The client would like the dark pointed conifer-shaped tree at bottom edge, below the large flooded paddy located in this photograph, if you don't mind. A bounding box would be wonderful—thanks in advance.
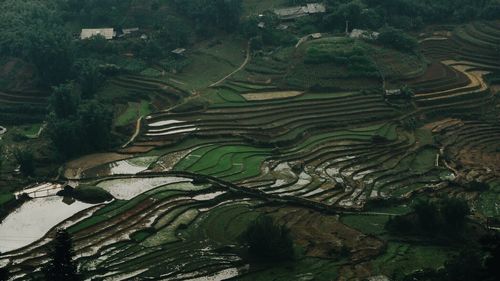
[42,229,82,281]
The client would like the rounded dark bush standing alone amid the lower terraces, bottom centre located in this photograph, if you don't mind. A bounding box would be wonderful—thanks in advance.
[242,216,294,261]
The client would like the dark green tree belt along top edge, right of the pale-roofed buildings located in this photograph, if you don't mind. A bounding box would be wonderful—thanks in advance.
[322,0,500,32]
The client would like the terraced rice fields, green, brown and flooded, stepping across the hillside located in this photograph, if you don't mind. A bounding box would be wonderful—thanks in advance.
[0,20,500,280]
